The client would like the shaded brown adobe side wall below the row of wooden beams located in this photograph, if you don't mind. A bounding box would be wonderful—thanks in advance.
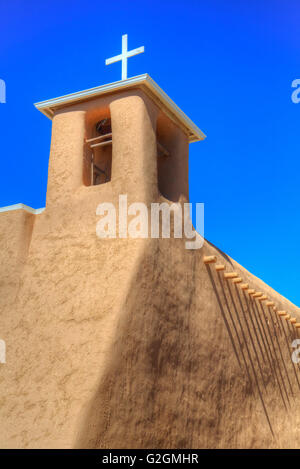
[76,239,300,449]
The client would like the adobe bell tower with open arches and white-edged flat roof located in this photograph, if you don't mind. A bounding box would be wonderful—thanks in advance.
[35,75,205,206]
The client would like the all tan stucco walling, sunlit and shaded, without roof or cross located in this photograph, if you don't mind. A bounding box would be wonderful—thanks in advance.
[0,91,300,448]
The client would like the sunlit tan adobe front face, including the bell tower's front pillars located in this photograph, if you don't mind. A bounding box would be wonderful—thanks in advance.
[0,92,186,448]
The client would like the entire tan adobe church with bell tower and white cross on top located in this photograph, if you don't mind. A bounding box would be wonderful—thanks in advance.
[0,38,300,449]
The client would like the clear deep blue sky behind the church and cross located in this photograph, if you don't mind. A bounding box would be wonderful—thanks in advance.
[0,0,300,305]
